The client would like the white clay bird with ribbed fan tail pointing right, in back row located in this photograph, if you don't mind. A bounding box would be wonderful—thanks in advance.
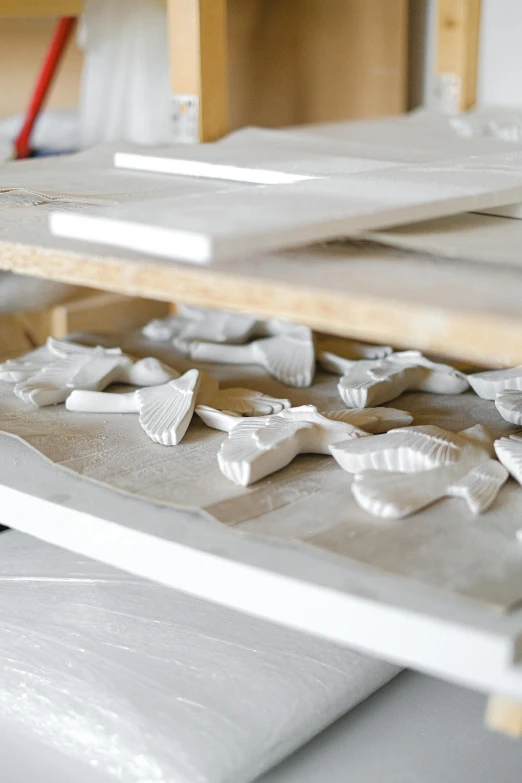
[179,326,315,387]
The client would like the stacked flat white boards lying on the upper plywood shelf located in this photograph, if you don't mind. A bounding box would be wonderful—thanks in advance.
[46,113,522,264]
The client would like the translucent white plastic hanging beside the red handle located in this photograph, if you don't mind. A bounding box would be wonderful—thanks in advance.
[79,0,172,147]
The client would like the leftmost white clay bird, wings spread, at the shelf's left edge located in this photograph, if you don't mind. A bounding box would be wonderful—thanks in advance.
[0,337,178,407]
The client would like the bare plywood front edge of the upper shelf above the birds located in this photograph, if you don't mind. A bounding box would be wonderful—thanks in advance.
[0,242,522,367]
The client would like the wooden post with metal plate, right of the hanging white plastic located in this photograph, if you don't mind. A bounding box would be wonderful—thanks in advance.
[167,0,228,141]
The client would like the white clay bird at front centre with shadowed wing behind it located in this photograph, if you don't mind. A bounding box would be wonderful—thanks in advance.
[218,405,411,487]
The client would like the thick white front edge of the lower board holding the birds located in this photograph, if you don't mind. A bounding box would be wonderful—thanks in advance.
[0,436,522,700]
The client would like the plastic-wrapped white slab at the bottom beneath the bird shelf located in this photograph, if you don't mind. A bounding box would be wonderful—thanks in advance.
[0,531,398,783]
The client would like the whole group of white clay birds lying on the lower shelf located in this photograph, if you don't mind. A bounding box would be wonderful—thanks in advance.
[0,307,522,518]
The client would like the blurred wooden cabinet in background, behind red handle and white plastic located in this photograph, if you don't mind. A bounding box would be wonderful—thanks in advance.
[0,0,408,140]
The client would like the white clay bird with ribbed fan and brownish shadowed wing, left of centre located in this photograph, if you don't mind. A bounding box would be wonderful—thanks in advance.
[66,370,290,446]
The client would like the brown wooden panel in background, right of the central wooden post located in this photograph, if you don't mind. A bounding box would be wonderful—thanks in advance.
[228,0,408,128]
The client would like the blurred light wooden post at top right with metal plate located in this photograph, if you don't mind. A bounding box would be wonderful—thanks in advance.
[437,0,482,110]
